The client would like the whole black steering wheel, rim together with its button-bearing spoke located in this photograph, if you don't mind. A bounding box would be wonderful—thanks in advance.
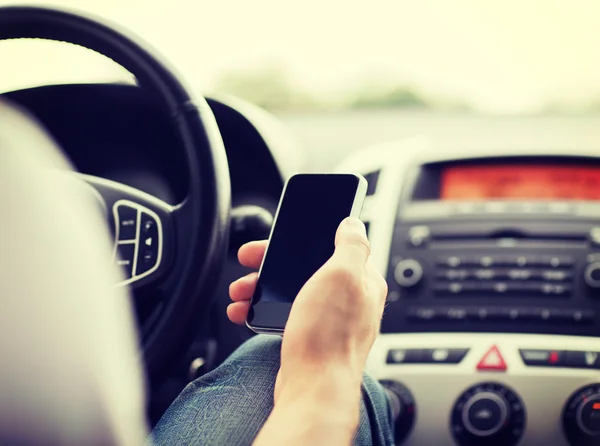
[0,7,231,381]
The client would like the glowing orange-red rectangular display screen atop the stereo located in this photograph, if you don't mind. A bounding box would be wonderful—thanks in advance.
[440,165,600,201]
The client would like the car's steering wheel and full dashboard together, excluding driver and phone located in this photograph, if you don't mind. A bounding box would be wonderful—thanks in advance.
[0,6,600,446]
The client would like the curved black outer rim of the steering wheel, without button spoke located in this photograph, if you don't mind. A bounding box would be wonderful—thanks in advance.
[0,7,231,382]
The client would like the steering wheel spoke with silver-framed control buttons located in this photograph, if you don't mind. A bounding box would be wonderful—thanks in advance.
[78,174,175,287]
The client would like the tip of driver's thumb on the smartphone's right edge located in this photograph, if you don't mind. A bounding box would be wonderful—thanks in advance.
[333,217,371,266]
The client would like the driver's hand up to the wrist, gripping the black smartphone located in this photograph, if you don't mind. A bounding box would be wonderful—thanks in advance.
[227,218,387,402]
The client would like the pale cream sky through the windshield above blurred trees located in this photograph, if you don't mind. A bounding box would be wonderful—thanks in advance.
[0,0,600,113]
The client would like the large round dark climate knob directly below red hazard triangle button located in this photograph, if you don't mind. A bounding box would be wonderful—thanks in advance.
[451,383,525,446]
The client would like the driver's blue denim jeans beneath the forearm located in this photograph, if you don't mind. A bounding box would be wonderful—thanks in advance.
[149,335,394,446]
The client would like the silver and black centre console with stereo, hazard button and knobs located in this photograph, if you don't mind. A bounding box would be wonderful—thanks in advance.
[339,145,600,446]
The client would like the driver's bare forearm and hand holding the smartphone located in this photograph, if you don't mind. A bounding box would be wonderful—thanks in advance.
[227,218,387,446]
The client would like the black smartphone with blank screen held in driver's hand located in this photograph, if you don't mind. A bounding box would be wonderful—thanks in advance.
[246,174,367,334]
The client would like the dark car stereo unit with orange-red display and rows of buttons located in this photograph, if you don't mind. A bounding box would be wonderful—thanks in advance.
[382,157,600,336]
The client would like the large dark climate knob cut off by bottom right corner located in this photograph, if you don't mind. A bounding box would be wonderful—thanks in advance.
[563,384,600,446]
